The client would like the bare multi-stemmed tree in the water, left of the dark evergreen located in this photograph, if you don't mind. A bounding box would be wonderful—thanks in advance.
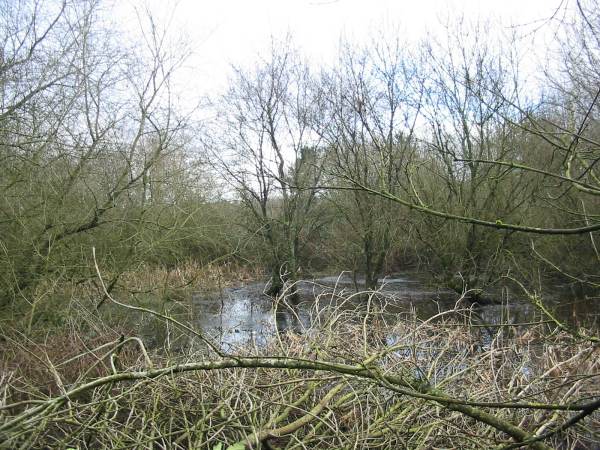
[209,44,321,294]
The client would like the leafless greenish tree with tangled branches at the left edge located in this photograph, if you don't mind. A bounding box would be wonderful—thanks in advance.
[0,1,196,314]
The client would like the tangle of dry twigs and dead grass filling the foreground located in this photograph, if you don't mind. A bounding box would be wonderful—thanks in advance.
[0,280,600,449]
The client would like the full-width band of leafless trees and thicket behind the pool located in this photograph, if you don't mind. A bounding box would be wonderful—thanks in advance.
[0,1,600,310]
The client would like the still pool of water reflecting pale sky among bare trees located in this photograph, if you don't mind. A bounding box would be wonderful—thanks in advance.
[192,273,600,351]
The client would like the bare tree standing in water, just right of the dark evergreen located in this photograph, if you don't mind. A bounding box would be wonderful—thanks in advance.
[320,40,422,289]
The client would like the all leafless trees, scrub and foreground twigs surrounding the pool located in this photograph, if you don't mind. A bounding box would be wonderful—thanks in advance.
[0,0,600,450]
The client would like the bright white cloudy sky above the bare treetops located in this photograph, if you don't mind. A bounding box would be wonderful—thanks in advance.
[115,0,564,108]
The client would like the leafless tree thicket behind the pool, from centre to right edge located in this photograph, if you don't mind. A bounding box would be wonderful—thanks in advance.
[208,17,600,296]
